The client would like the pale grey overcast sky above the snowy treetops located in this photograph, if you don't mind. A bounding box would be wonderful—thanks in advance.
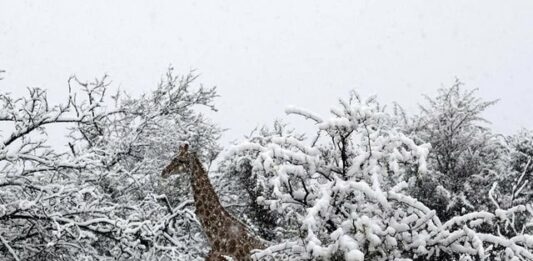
[0,0,533,145]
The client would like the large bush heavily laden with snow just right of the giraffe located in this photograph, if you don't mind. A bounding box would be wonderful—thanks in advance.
[228,90,533,260]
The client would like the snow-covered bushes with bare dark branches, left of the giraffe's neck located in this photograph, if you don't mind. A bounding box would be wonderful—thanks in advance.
[0,70,220,260]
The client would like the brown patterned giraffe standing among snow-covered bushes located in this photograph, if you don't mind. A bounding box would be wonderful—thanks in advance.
[161,144,264,261]
